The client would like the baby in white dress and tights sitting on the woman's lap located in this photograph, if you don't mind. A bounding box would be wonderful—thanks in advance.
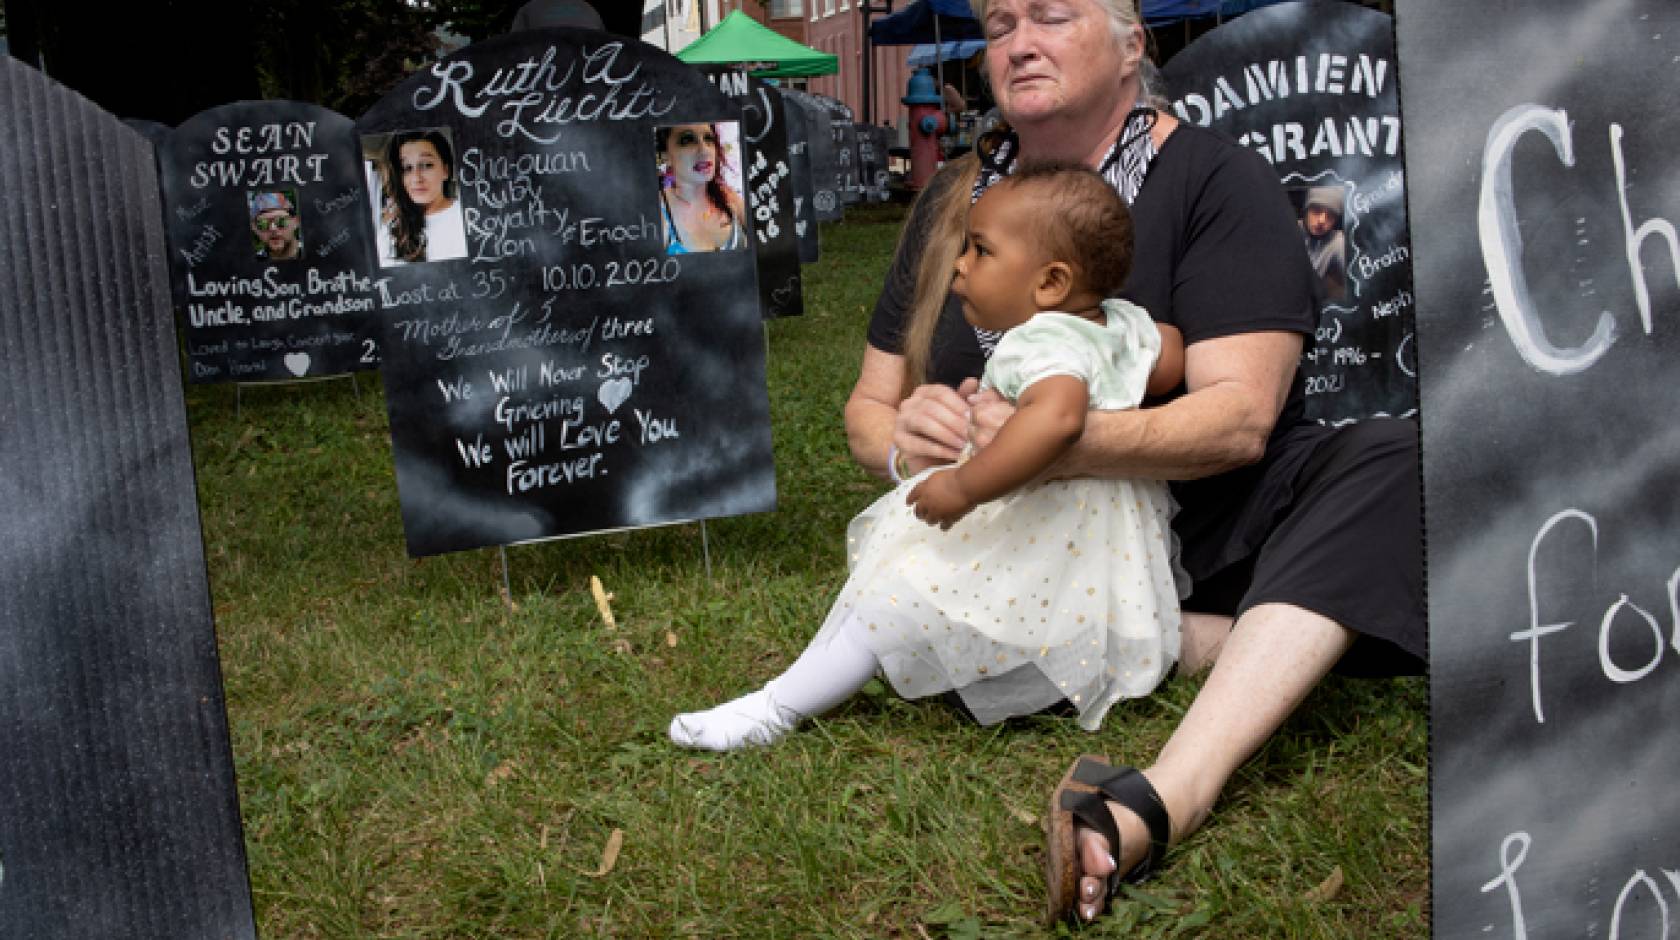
[670,166,1183,750]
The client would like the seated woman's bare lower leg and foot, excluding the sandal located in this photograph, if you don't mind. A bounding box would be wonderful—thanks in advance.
[1079,604,1354,920]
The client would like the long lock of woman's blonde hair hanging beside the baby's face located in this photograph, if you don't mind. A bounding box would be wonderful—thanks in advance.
[899,153,979,398]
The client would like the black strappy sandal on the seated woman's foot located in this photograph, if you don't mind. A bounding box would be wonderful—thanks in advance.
[1045,754,1173,925]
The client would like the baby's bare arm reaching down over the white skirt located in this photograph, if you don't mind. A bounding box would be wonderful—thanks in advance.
[907,376,1090,529]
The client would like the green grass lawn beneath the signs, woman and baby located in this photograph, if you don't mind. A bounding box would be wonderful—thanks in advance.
[188,208,1428,938]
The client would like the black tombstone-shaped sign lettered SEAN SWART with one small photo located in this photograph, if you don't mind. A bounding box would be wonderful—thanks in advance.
[158,101,380,383]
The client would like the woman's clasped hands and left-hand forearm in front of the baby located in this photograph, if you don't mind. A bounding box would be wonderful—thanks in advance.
[845,346,978,480]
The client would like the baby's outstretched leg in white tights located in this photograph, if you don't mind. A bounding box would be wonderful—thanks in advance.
[670,616,879,750]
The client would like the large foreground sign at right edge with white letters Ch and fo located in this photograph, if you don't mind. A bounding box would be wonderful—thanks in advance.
[1396,0,1680,938]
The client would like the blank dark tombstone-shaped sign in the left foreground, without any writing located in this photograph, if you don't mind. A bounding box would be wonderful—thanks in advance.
[0,55,257,940]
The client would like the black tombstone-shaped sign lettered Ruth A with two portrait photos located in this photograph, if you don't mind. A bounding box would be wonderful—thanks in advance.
[358,30,774,556]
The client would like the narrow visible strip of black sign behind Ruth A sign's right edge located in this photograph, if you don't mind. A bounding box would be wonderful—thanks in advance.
[702,67,805,319]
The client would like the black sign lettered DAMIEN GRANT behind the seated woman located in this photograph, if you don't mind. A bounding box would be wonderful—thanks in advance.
[1163,0,1418,425]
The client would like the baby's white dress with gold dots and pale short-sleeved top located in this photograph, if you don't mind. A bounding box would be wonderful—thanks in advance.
[818,300,1179,730]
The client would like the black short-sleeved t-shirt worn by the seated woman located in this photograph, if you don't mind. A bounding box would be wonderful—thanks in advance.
[869,124,1317,577]
